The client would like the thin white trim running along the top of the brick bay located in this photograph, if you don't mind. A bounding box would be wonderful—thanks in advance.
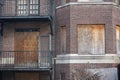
[56,2,117,9]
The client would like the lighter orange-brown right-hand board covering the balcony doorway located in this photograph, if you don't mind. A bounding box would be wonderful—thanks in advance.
[24,32,39,65]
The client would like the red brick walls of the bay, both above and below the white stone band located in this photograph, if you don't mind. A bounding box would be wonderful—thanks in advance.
[55,0,120,80]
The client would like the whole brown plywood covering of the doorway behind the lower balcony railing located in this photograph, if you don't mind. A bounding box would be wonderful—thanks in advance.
[14,32,39,66]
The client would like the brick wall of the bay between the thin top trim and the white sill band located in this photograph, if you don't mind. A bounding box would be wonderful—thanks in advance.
[56,5,116,54]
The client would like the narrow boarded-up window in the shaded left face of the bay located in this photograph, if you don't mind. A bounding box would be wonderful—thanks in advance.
[61,26,66,53]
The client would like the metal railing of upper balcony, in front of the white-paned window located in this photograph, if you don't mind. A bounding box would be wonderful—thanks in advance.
[0,0,51,17]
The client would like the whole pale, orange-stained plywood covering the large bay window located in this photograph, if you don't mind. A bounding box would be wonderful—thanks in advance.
[78,25,105,54]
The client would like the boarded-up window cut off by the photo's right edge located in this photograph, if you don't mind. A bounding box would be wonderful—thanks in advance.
[116,26,120,53]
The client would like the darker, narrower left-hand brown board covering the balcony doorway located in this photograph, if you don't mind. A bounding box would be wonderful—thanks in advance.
[14,32,25,66]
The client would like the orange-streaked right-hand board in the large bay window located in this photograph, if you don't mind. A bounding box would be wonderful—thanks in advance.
[92,25,105,54]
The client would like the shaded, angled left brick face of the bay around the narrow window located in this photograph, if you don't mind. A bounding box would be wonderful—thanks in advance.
[55,6,70,54]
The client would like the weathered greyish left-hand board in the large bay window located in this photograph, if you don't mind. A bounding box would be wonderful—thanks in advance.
[78,25,92,54]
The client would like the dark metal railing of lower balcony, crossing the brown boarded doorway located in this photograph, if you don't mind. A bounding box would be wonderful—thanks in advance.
[0,51,52,69]
